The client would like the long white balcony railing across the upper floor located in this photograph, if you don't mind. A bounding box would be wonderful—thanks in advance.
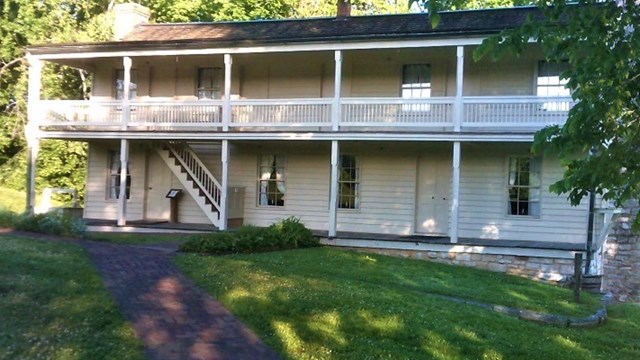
[39,96,573,131]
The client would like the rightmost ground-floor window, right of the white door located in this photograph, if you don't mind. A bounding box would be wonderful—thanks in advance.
[505,155,542,219]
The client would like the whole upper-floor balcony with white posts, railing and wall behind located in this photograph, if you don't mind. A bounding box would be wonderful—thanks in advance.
[30,38,573,137]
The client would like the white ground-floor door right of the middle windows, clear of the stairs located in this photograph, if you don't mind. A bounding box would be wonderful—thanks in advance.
[415,153,452,235]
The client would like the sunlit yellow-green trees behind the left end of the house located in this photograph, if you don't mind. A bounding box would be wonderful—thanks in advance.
[0,0,111,202]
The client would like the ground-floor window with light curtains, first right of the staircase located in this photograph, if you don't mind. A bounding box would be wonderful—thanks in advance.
[258,155,286,206]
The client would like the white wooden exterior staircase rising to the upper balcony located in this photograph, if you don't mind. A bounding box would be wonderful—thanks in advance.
[156,142,222,227]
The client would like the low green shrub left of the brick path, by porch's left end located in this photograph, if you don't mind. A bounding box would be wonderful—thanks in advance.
[13,212,86,236]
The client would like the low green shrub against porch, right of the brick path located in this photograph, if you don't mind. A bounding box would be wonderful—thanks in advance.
[180,217,319,254]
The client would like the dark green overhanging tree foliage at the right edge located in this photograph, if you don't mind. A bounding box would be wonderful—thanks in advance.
[470,0,640,228]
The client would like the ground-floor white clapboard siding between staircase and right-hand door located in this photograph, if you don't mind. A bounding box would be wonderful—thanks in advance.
[229,149,415,234]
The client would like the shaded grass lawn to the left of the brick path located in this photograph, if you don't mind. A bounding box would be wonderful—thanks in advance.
[0,235,143,359]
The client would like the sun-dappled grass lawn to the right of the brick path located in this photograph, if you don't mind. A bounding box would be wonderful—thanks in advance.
[175,248,640,360]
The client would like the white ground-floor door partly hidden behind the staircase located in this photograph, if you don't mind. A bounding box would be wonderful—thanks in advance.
[145,151,173,220]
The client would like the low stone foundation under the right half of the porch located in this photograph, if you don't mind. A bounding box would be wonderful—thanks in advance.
[349,247,573,282]
